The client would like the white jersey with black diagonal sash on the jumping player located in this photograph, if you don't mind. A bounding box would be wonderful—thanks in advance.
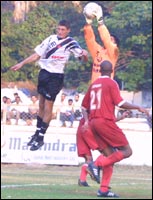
[34,35,83,73]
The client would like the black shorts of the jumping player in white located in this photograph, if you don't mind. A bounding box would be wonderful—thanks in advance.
[37,69,64,101]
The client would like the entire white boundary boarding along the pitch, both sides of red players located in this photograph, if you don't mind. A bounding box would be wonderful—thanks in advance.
[1,120,152,166]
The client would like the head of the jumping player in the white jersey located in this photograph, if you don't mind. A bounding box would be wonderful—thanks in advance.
[57,20,70,39]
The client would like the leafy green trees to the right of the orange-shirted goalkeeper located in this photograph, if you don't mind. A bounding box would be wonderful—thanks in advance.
[106,1,152,91]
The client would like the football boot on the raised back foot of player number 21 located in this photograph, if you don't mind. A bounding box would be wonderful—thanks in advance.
[87,161,100,183]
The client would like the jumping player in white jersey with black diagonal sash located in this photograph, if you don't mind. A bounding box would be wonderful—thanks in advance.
[11,20,88,151]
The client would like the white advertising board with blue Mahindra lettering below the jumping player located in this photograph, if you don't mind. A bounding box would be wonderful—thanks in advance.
[1,131,78,165]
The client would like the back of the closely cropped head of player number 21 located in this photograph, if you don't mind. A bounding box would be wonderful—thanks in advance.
[100,60,113,75]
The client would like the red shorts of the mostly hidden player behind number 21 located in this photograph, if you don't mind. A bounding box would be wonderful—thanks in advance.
[76,119,98,157]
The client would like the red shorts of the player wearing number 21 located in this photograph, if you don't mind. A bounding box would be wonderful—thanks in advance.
[90,118,129,149]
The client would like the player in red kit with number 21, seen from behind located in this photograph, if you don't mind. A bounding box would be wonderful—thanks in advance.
[82,60,149,197]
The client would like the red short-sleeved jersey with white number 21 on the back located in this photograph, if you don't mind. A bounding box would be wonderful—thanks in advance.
[82,76,125,120]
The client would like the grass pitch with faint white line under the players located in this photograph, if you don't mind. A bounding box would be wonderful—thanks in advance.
[1,164,152,199]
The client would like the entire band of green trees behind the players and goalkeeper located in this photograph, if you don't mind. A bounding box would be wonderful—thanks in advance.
[1,1,152,91]
